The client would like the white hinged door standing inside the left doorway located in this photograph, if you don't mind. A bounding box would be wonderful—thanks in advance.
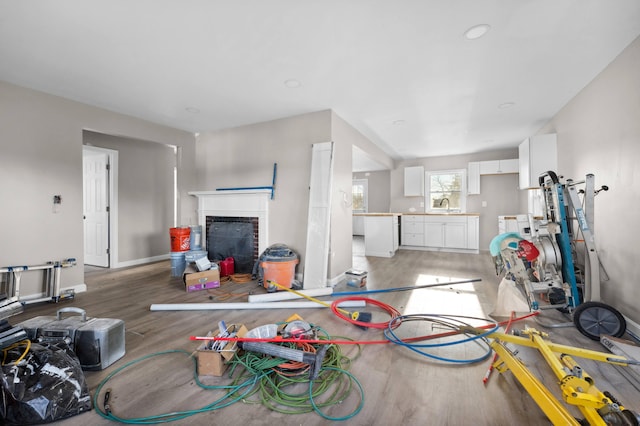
[82,148,109,267]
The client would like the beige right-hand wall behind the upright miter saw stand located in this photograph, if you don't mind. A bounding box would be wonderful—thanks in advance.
[540,38,640,332]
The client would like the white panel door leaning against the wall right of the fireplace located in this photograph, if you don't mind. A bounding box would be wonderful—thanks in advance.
[303,142,333,289]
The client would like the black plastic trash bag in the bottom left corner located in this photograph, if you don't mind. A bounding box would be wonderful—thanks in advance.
[0,341,91,425]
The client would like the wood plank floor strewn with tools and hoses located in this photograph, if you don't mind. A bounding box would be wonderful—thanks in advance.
[6,240,640,426]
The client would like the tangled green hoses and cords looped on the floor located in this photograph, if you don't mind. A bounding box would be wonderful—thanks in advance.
[93,336,364,424]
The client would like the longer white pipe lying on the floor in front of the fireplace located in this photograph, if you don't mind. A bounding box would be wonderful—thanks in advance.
[149,300,366,311]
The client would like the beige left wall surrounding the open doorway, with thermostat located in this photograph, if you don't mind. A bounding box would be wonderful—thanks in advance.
[0,82,194,295]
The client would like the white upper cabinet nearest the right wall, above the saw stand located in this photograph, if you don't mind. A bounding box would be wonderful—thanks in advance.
[518,133,558,189]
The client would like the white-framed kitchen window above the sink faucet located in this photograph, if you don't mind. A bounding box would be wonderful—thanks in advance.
[425,169,467,213]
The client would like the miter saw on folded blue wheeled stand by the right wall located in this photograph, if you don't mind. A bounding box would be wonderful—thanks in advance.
[492,171,626,340]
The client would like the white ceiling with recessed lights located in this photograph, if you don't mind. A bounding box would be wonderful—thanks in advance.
[0,0,640,170]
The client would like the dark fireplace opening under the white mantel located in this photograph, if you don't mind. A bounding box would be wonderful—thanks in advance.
[206,216,259,273]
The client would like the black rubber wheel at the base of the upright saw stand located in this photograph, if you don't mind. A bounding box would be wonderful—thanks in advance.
[573,302,627,341]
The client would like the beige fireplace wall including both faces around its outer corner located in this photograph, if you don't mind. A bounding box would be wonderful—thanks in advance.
[193,110,393,280]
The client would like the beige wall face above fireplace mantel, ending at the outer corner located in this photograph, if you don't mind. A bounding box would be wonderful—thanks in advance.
[196,111,331,280]
